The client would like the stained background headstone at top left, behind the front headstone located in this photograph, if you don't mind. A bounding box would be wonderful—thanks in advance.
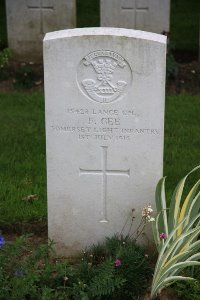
[6,0,76,61]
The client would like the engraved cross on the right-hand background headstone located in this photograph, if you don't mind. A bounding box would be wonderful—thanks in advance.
[121,0,149,29]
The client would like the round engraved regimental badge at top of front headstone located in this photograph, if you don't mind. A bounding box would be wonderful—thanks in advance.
[77,50,132,103]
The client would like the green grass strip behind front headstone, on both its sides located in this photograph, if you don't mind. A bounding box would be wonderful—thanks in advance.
[0,92,200,225]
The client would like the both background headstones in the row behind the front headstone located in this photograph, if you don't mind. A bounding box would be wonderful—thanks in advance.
[6,0,170,61]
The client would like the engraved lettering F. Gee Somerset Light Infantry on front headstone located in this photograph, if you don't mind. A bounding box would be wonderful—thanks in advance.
[50,107,161,142]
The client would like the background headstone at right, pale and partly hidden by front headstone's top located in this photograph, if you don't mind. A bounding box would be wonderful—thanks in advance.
[101,0,170,33]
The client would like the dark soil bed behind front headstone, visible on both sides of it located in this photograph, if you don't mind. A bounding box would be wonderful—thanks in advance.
[0,61,200,95]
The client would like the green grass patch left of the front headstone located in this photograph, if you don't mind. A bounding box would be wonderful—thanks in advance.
[0,92,46,224]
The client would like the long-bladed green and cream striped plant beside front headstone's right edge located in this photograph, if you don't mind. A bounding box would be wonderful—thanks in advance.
[151,166,200,298]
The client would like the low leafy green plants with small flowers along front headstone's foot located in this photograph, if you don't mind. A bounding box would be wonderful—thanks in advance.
[0,236,151,300]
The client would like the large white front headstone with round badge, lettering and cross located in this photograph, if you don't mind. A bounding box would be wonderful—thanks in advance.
[44,28,166,255]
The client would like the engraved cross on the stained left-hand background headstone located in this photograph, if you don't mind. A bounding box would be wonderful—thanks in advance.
[27,0,54,34]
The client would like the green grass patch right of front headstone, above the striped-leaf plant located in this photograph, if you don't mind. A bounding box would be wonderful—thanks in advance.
[164,95,200,180]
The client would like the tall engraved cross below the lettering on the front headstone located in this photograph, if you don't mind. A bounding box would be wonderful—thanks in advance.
[79,146,130,223]
